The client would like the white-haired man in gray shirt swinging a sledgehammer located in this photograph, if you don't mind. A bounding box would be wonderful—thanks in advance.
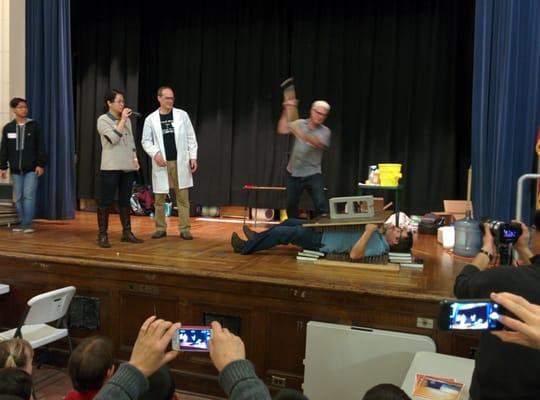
[277,99,331,218]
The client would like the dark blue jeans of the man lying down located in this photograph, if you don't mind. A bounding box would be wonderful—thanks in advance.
[242,218,322,254]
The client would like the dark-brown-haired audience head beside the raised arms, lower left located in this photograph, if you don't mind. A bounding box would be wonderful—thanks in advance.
[68,336,114,392]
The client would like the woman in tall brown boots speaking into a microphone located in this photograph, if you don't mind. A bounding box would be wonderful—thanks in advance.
[97,89,143,248]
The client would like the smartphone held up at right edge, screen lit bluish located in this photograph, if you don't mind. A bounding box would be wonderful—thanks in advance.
[439,299,505,331]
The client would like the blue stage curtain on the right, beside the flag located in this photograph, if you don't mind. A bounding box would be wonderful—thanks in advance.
[471,0,540,222]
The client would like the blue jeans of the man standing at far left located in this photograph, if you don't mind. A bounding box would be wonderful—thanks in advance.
[11,171,38,229]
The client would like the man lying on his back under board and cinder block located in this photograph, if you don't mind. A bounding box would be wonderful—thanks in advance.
[231,219,412,260]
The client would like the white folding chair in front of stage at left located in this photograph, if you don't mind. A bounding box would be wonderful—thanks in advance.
[0,286,76,352]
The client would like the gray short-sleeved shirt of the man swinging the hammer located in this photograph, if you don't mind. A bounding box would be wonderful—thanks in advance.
[287,119,331,177]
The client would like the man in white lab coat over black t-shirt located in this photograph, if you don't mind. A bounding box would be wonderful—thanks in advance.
[141,86,198,240]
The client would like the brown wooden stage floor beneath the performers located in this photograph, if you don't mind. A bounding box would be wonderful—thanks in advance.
[0,212,466,300]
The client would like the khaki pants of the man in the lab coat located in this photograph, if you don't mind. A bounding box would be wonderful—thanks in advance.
[154,161,191,233]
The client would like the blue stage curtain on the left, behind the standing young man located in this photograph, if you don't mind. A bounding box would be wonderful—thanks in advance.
[26,0,75,219]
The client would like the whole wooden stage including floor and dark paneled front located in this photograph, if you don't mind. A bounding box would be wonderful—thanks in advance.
[0,212,477,395]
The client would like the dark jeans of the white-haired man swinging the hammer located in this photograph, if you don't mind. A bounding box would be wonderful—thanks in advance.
[287,174,328,218]
